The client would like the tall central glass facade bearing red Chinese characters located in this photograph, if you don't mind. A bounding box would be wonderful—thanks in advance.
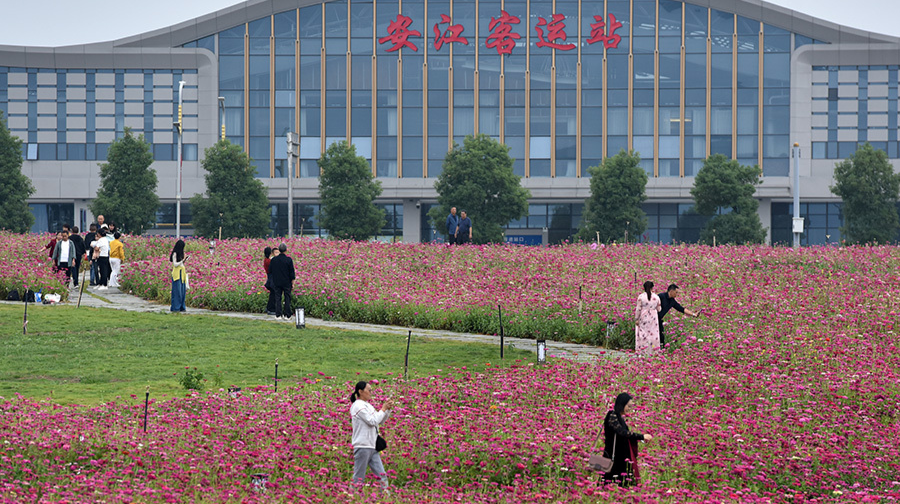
[192,0,800,178]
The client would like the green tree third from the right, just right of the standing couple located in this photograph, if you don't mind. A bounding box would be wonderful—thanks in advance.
[578,149,647,243]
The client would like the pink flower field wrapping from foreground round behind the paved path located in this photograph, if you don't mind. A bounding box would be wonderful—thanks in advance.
[0,236,900,503]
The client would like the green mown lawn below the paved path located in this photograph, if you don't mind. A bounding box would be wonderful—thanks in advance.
[0,304,534,404]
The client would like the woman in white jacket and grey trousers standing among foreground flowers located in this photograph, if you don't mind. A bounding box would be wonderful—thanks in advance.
[350,381,391,489]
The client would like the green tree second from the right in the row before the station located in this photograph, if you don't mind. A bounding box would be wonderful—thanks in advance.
[691,154,766,244]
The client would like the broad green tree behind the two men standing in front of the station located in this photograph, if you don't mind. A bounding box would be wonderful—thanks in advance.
[428,134,531,243]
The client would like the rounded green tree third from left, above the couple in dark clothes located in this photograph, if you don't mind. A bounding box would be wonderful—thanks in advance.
[191,139,269,238]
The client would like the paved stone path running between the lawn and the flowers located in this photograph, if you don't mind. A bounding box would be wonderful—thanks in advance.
[31,286,629,361]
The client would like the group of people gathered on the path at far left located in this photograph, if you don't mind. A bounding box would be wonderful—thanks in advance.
[44,215,125,290]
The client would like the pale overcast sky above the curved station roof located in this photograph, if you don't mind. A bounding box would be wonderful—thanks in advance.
[0,0,900,46]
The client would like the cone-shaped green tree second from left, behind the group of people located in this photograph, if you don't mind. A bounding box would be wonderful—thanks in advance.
[89,128,159,234]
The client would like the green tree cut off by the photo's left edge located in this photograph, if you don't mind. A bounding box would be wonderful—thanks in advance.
[0,111,34,233]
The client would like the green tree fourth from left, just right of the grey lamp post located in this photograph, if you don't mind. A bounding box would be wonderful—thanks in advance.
[319,140,385,241]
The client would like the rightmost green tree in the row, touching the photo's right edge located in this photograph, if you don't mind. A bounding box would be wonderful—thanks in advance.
[831,142,900,243]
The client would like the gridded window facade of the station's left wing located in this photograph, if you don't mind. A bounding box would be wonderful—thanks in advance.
[0,67,198,161]
